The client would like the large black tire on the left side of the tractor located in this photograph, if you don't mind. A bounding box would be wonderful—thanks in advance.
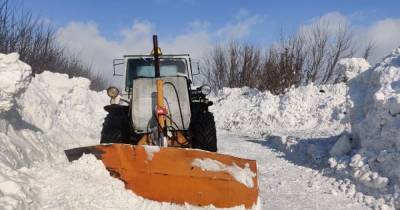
[100,104,132,144]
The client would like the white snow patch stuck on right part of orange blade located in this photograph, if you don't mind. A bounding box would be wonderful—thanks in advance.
[192,158,256,188]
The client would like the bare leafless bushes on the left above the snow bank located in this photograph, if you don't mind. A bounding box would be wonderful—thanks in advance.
[0,0,107,90]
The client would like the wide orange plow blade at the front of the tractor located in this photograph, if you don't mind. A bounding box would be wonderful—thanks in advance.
[65,144,258,209]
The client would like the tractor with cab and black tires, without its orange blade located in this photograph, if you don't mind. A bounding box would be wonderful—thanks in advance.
[100,34,217,152]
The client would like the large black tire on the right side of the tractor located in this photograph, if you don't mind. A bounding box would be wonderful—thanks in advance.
[190,110,217,152]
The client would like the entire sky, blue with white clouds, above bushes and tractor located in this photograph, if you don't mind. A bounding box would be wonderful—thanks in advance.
[9,0,400,79]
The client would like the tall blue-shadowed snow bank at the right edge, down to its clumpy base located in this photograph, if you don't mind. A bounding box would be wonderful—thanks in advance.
[348,48,400,192]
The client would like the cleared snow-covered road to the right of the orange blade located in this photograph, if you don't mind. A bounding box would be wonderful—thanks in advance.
[218,130,370,210]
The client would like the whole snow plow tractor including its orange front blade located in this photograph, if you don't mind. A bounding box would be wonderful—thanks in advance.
[65,35,259,209]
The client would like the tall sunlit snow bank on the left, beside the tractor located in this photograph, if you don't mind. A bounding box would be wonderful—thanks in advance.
[0,53,108,209]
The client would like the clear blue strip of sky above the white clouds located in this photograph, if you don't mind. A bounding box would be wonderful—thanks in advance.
[14,0,400,43]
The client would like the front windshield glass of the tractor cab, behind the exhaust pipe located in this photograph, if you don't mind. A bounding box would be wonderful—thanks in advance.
[126,58,187,88]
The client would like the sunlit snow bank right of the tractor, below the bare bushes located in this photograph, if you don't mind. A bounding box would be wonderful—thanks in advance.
[211,84,347,137]
